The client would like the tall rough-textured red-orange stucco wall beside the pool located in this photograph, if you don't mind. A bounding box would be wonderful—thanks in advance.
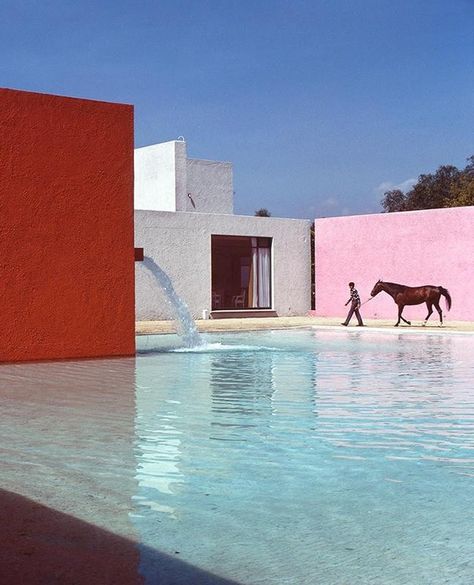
[0,89,135,361]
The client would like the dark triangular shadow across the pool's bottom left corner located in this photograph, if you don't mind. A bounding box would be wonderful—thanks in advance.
[0,490,243,585]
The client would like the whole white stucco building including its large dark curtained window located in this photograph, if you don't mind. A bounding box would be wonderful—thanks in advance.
[135,140,311,321]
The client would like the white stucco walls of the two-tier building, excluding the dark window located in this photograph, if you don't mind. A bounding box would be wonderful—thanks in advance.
[135,140,311,321]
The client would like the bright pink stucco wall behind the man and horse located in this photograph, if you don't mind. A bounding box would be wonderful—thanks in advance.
[315,207,474,321]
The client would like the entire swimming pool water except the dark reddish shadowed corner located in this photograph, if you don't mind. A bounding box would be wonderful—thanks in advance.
[0,329,474,585]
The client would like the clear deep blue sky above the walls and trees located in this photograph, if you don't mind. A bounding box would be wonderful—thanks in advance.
[0,0,474,218]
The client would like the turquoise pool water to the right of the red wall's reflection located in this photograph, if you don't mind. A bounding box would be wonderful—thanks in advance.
[133,329,474,585]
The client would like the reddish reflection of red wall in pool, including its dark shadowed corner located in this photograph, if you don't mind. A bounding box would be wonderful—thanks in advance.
[0,358,142,585]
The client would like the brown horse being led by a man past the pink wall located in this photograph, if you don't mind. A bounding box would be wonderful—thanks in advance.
[370,280,451,327]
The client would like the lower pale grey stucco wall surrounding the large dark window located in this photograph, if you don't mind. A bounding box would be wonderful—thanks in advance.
[135,210,311,321]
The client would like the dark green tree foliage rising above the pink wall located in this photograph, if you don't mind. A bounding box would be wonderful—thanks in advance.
[381,156,474,212]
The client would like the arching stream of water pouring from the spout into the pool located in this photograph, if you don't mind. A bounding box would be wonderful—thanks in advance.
[143,256,203,347]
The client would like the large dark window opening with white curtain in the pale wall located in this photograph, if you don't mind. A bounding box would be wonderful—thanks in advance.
[211,235,272,311]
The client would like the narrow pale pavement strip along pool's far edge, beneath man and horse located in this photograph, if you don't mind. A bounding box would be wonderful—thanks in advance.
[135,317,474,335]
